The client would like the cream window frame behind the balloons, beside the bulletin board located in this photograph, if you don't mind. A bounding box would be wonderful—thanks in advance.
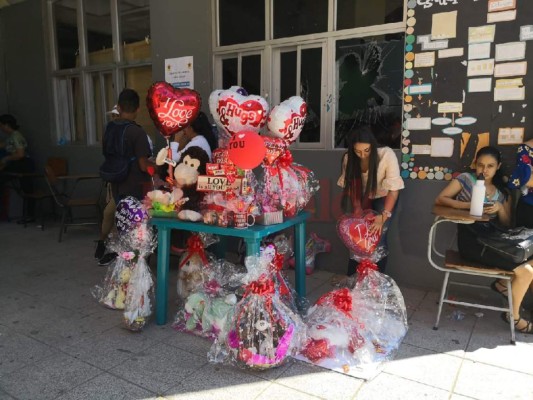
[211,0,408,151]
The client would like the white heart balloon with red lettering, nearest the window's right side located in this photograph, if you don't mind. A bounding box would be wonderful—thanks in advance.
[267,96,307,143]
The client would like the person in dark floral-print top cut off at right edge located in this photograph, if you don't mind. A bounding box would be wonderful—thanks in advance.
[509,139,533,228]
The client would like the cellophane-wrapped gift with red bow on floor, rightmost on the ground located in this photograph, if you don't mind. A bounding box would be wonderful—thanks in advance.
[297,260,407,379]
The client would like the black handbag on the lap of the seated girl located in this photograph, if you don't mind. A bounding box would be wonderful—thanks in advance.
[477,227,533,264]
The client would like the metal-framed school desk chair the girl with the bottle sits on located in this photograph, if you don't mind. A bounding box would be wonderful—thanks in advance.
[428,207,515,344]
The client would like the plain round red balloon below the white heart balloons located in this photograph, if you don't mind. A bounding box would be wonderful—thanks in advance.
[228,131,266,169]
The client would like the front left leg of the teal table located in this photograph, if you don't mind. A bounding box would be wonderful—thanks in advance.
[155,227,171,325]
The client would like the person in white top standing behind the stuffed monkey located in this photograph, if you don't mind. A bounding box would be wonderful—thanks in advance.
[170,111,217,162]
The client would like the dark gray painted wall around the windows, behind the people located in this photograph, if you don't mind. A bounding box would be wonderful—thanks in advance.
[0,0,454,288]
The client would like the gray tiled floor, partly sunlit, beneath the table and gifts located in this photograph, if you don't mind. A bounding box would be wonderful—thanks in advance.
[0,223,533,400]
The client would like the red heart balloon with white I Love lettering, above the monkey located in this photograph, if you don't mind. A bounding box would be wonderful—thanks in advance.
[146,82,202,138]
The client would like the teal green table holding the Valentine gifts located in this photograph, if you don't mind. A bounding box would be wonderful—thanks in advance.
[150,211,309,325]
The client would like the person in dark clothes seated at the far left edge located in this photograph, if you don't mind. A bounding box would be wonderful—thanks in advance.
[0,114,35,223]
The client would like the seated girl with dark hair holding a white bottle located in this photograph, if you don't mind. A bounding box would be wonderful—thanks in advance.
[435,146,533,333]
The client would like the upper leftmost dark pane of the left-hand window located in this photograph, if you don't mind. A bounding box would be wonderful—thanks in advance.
[54,0,79,69]
